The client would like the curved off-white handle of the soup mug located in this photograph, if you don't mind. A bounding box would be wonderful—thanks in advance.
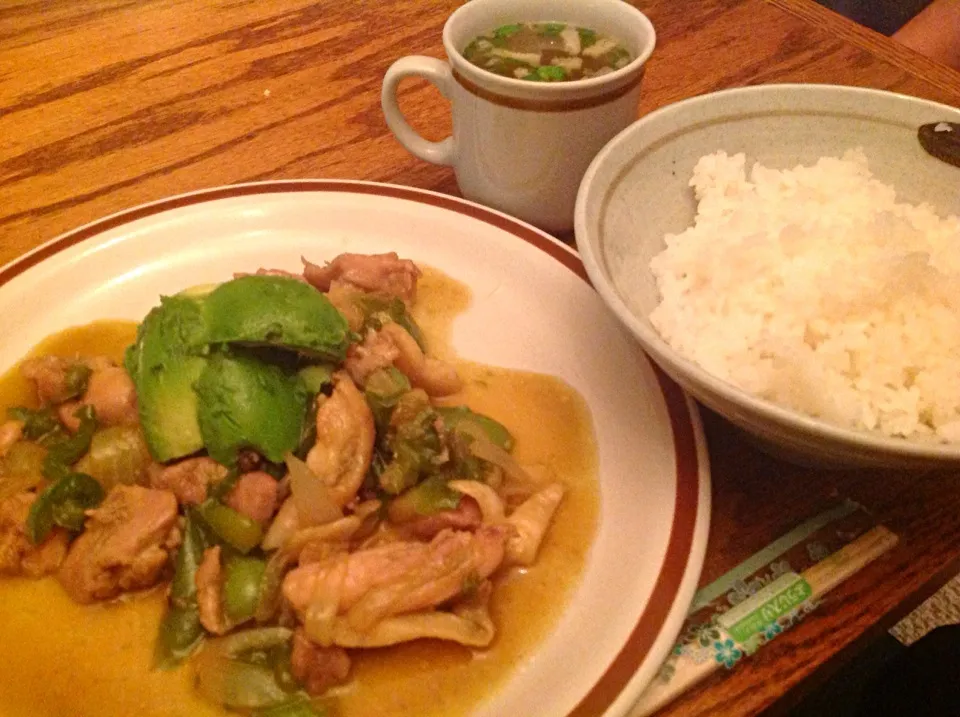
[380,55,454,166]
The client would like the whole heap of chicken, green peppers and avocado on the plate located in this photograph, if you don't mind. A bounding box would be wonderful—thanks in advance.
[0,254,564,717]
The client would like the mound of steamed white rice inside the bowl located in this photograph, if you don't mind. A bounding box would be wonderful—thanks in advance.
[650,150,960,442]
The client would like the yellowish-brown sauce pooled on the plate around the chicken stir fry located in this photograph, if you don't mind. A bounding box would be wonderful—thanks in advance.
[0,269,599,717]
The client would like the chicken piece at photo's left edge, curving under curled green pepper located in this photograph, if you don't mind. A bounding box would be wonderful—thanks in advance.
[0,493,70,578]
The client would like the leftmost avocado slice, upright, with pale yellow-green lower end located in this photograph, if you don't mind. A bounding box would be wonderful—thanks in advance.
[124,295,207,462]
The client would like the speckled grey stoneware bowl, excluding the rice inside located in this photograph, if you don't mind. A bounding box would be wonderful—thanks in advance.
[575,85,960,468]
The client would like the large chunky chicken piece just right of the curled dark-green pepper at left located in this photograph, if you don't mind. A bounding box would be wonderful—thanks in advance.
[58,485,179,603]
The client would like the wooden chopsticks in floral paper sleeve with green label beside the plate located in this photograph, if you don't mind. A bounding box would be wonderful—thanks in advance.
[630,502,897,717]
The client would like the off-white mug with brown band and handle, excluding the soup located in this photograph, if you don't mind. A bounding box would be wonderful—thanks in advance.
[381,0,656,232]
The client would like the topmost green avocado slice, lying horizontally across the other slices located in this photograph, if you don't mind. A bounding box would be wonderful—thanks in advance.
[204,276,350,361]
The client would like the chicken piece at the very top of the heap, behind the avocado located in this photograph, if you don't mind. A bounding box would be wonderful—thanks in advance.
[302,252,420,303]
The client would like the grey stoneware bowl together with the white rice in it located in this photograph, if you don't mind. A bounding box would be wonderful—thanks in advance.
[575,85,960,468]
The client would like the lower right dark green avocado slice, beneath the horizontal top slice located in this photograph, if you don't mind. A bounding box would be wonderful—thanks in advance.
[196,352,308,466]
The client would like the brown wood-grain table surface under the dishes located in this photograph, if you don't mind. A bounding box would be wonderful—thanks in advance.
[0,0,960,716]
